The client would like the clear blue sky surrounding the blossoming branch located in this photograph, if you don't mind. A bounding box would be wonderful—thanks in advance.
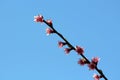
[0,0,120,80]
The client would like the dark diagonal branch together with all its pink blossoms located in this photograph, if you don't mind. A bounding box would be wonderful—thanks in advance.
[34,15,107,80]
